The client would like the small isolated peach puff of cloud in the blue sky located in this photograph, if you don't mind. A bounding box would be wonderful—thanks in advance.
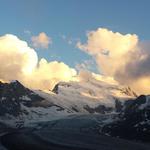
[31,32,52,49]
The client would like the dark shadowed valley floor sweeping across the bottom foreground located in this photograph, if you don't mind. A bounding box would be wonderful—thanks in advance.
[1,115,150,150]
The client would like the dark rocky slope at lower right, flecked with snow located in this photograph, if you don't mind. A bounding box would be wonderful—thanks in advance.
[102,95,150,142]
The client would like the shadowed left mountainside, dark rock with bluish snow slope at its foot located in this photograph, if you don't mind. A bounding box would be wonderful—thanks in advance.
[0,81,70,126]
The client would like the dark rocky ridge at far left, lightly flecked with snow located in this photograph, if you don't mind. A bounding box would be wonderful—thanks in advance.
[0,81,43,116]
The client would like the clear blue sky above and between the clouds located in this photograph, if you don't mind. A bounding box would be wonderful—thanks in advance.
[0,0,150,72]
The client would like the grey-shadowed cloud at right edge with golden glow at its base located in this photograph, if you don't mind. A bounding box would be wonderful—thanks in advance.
[115,42,150,94]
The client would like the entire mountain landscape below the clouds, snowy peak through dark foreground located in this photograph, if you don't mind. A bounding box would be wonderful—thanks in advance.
[0,79,150,150]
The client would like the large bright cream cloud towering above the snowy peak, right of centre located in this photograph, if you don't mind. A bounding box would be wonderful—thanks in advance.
[77,28,138,76]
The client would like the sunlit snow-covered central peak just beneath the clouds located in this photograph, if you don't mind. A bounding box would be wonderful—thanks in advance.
[49,79,135,114]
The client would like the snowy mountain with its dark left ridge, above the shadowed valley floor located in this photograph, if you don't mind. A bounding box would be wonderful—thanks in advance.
[0,80,135,125]
